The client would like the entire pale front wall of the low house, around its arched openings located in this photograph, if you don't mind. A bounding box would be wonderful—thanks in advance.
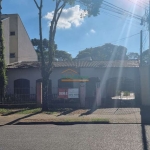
[7,68,139,94]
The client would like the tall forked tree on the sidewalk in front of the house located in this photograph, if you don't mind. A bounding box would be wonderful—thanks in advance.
[34,0,103,110]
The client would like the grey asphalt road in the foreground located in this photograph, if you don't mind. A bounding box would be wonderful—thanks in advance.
[0,124,150,150]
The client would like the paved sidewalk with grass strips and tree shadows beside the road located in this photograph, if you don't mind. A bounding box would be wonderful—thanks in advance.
[0,108,145,126]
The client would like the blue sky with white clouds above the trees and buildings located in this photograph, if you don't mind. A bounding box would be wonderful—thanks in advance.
[2,0,148,57]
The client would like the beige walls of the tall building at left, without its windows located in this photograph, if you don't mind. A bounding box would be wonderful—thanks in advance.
[2,14,38,63]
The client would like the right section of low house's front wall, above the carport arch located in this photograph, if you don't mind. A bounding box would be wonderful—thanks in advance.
[80,67,140,98]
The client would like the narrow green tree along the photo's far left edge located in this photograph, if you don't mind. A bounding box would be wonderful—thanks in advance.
[0,1,7,98]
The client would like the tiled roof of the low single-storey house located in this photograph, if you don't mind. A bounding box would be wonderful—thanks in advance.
[7,60,139,68]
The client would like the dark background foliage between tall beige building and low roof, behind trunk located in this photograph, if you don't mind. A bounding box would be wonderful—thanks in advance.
[31,38,72,62]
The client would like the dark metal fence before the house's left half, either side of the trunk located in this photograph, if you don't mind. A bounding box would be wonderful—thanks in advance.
[0,87,80,107]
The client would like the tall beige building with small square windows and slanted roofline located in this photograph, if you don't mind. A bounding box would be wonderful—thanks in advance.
[2,14,37,64]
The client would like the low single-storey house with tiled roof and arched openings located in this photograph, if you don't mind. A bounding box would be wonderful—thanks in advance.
[7,60,140,105]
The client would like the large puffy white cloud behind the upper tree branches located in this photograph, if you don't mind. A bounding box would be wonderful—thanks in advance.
[44,5,86,29]
